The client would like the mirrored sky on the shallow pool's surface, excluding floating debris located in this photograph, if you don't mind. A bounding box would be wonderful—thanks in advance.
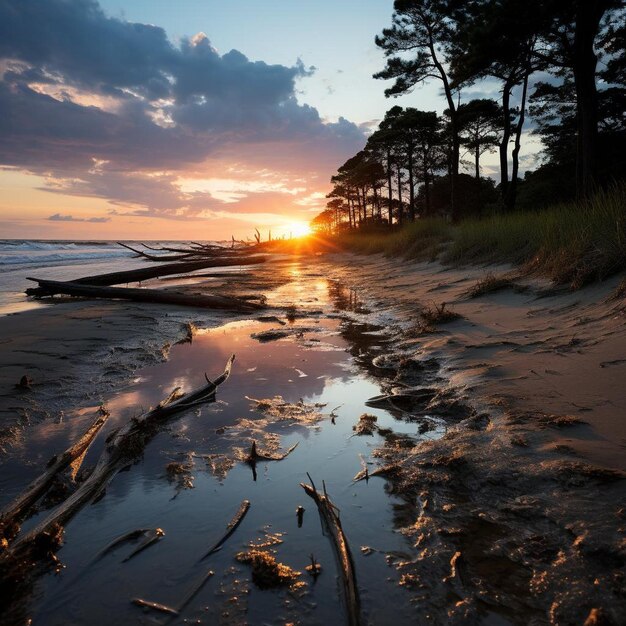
[23,281,434,625]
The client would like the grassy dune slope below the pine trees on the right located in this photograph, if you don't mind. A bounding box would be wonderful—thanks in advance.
[336,183,626,287]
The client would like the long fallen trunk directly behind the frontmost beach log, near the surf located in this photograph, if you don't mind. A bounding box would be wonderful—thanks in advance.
[26,255,267,296]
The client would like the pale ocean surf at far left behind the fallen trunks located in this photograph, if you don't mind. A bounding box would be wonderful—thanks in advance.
[0,239,180,315]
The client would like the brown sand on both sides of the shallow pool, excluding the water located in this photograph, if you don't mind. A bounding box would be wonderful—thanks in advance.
[0,254,626,624]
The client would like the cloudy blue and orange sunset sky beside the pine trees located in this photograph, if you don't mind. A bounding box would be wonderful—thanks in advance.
[0,0,532,239]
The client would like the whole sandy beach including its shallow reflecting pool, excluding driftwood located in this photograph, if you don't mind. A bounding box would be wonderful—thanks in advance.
[0,246,626,624]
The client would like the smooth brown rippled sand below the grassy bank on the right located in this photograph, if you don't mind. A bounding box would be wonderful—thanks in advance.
[322,257,626,470]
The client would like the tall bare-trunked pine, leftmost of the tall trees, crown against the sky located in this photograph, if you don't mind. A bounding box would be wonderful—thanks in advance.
[374,0,460,220]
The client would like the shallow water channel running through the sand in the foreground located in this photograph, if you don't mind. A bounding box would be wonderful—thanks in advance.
[25,281,441,625]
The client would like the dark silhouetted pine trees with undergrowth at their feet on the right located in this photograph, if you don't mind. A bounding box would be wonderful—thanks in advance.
[312,0,626,240]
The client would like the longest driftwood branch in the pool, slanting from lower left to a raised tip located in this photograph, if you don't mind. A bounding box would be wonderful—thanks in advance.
[3,355,235,558]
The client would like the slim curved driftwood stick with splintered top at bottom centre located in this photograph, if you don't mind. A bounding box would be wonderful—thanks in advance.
[300,474,361,626]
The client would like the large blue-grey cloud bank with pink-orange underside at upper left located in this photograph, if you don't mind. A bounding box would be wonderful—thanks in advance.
[0,0,365,219]
